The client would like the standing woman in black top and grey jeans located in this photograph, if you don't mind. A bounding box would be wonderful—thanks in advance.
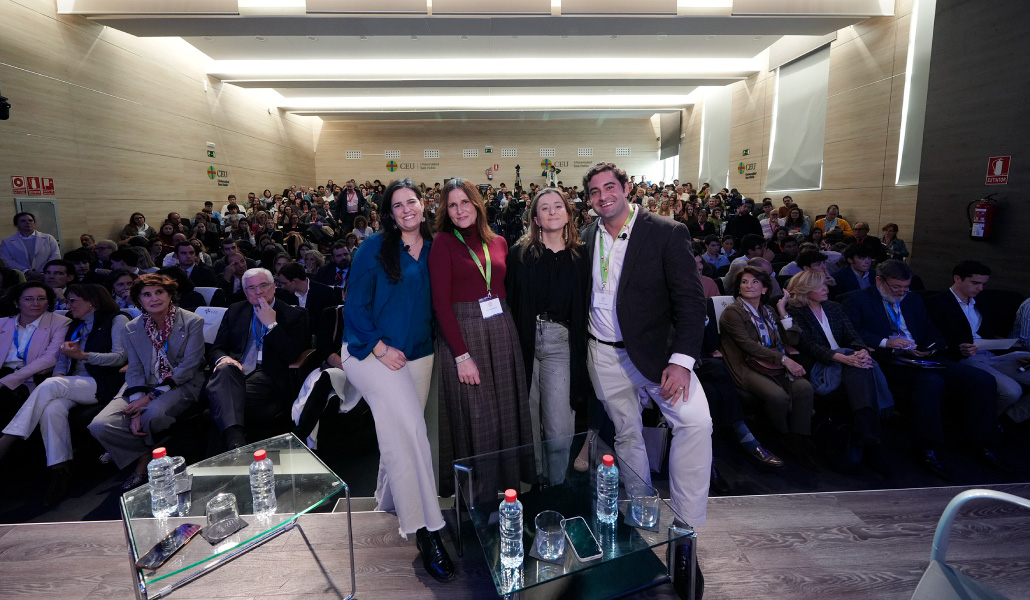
[505,187,590,485]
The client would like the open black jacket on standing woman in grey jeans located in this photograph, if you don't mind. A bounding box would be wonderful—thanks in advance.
[505,241,593,410]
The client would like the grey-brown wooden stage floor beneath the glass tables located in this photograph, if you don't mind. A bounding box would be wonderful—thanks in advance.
[0,484,1030,600]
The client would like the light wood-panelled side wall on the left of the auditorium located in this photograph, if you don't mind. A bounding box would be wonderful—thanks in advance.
[0,0,319,250]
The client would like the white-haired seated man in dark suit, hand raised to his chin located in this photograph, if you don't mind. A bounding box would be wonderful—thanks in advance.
[207,269,311,449]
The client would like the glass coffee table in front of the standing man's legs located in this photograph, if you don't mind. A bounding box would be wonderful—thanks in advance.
[454,433,696,600]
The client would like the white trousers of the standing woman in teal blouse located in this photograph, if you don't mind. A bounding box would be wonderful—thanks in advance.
[343,353,444,536]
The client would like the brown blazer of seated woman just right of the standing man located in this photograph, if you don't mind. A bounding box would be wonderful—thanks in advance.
[719,303,801,389]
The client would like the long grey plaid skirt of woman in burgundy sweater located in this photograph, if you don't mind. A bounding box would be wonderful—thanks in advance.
[437,298,536,499]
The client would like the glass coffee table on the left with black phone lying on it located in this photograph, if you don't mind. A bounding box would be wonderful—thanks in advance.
[121,433,354,600]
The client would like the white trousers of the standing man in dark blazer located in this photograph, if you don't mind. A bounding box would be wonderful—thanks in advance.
[587,340,712,526]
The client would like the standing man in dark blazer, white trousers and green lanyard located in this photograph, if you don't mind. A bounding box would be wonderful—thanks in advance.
[582,163,712,587]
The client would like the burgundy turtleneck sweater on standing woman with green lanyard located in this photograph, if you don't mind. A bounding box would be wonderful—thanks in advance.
[430,226,508,356]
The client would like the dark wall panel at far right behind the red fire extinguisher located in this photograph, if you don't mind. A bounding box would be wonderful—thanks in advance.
[913,0,1030,294]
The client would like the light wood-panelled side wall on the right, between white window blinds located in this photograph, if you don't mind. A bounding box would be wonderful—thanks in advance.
[680,0,918,251]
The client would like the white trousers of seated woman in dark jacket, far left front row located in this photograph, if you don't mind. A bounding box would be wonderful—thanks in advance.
[3,377,97,466]
